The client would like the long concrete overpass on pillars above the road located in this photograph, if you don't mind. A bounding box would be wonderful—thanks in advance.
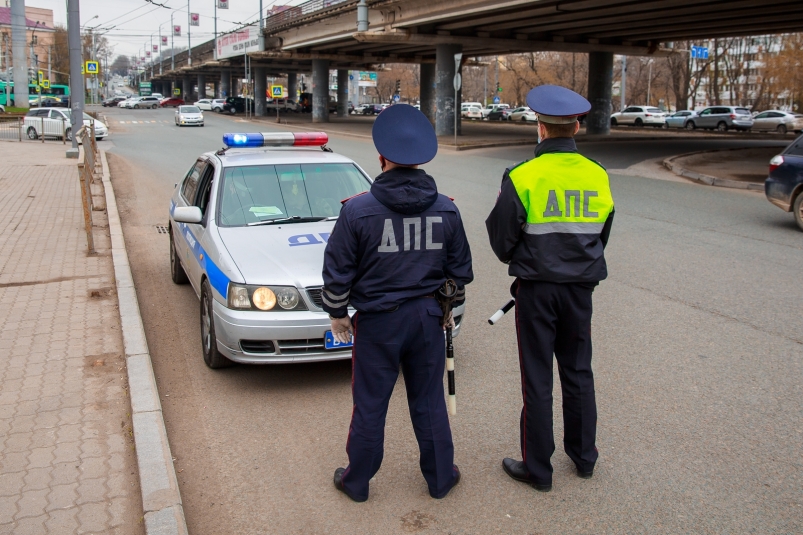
[148,0,803,135]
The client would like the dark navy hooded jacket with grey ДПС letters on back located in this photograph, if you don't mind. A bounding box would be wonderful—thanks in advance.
[322,167,474,318]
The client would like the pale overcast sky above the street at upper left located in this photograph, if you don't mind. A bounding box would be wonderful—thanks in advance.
[28,0,303,56]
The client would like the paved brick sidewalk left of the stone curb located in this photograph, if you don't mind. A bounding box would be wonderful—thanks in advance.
[0,142,144,535]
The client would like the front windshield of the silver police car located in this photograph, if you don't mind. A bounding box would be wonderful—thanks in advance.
[218,163,371,226]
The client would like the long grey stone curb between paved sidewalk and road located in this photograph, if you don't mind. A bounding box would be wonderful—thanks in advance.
[100,150,188,535]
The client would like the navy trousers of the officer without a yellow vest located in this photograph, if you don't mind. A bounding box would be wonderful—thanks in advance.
[343,297,455,498]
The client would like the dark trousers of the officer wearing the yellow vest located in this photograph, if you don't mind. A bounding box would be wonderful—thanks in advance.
[514,279,598,484]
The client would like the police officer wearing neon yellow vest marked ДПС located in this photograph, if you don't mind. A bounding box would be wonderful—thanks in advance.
[485,85,614,492]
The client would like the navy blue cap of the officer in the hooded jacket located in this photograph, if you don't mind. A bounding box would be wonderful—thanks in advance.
[371,104,438,165]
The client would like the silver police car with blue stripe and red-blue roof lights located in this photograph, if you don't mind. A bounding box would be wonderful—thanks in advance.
[169,132,463,368]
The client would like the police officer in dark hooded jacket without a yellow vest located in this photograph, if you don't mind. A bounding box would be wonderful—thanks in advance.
[322,104,474,502]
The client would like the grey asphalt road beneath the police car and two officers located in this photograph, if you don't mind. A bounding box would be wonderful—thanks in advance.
[102,105,803,534]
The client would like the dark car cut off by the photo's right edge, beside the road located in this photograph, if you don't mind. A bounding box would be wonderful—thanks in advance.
[764,136,803,230]
